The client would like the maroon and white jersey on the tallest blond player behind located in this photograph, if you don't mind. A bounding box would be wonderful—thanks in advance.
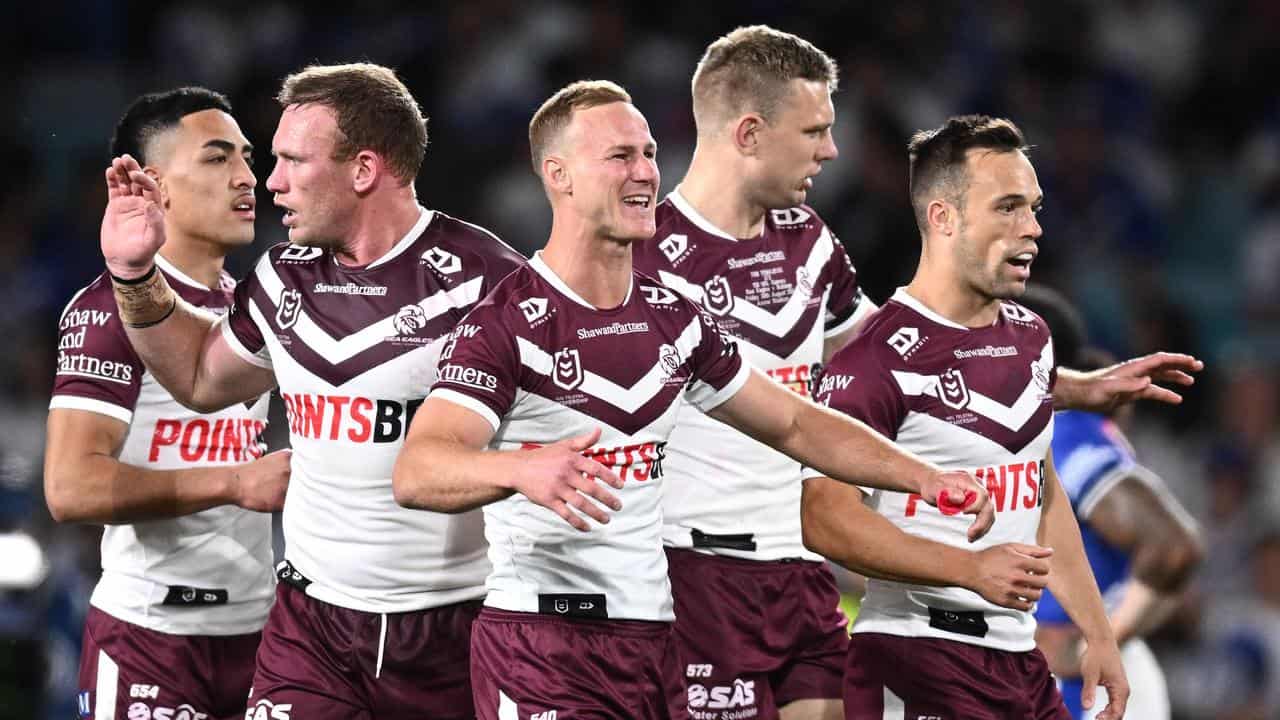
[635,190,870,560]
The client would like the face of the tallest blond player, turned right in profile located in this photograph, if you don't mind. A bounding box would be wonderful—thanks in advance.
[748,79,840,210]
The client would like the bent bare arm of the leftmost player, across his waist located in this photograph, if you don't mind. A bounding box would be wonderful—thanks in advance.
[45,407,289,524]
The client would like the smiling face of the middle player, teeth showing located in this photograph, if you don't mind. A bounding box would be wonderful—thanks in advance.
[549,102,659,243]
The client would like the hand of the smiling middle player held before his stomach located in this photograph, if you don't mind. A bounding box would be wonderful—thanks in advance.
[513,428,622,533]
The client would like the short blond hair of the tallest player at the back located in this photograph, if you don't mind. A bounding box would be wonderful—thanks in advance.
[694,26,840,132]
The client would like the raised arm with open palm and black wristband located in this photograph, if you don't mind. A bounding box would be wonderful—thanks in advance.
[101,155,275,413]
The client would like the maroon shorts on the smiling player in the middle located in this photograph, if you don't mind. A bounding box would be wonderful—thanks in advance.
[471,607,689,720]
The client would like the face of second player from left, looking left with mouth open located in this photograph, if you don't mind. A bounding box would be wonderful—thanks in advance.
[266,104,358,247]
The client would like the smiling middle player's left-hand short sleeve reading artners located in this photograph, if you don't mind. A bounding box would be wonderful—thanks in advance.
[428,305,520,430]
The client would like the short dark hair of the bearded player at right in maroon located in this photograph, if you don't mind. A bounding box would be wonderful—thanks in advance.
[906,115,1029,233]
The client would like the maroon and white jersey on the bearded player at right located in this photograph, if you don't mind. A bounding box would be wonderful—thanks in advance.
[806,290,1056,652]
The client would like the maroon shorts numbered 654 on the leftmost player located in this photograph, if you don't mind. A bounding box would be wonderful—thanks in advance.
[79,607,261,720]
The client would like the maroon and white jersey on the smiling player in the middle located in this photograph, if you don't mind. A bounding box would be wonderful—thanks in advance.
[431,255,749,621]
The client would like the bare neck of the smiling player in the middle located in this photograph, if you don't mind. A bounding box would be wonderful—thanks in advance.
[541,218,631,310]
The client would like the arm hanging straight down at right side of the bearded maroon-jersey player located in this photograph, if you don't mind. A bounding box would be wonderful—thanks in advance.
[1036,452,1129,720]
